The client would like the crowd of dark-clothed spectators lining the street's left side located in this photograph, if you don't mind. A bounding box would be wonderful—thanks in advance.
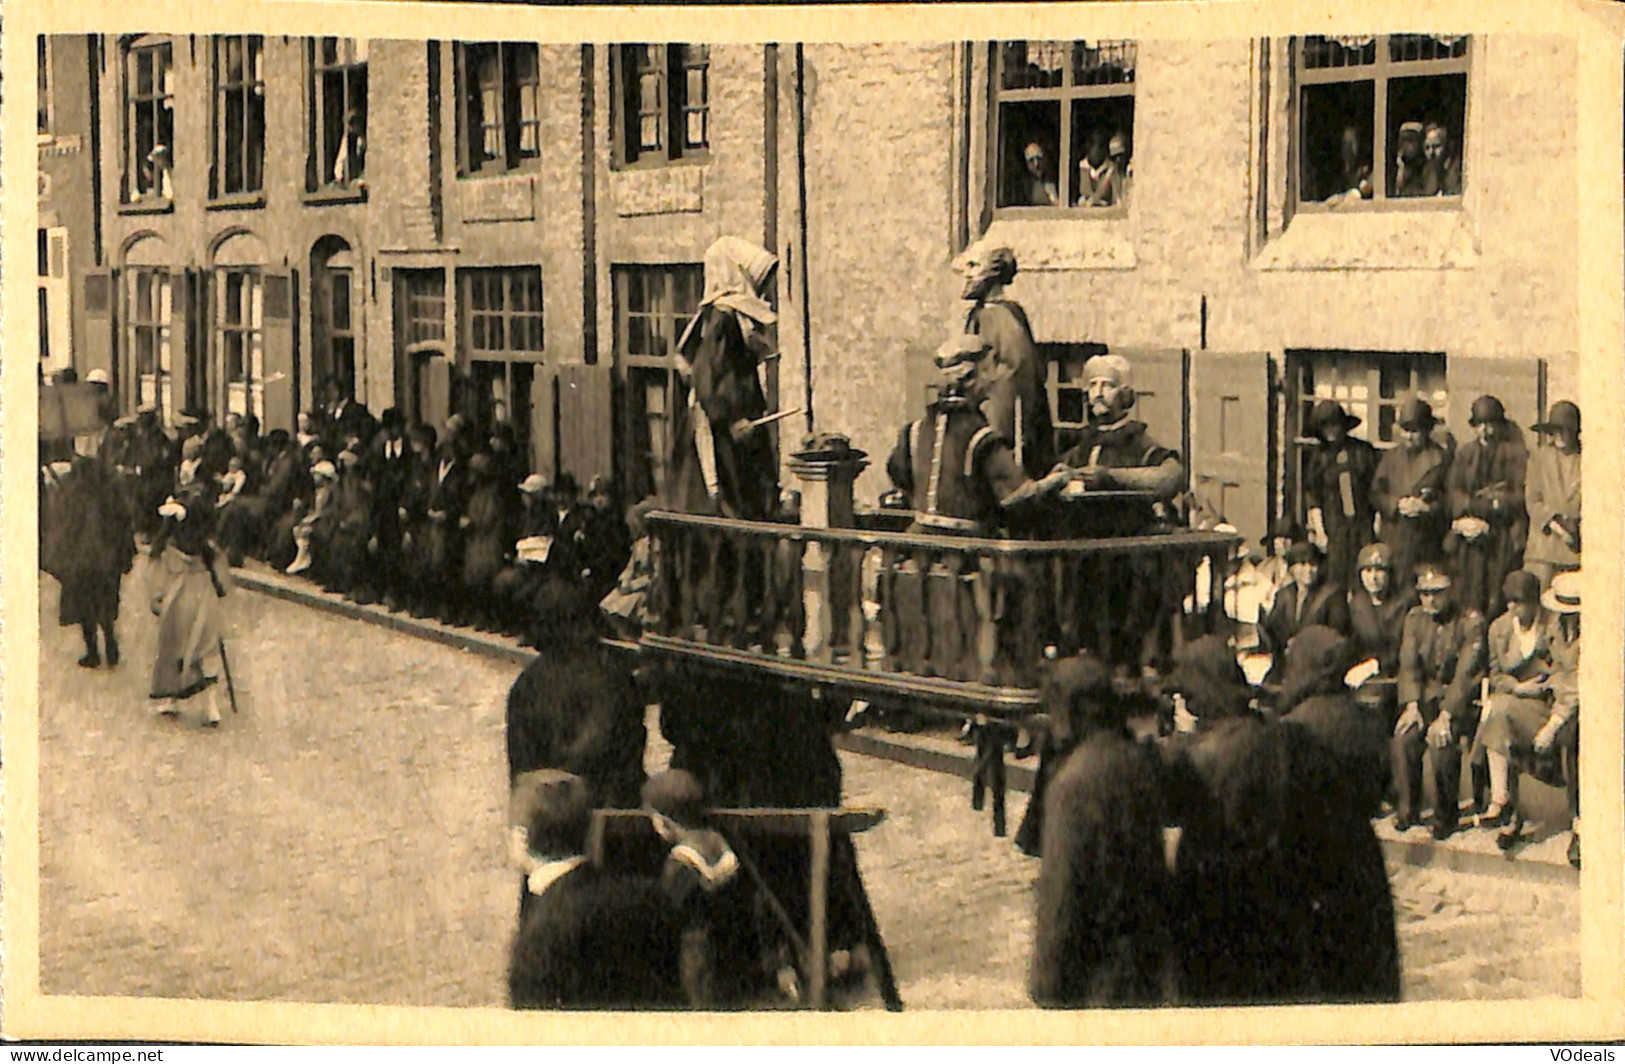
[104,383,648,645]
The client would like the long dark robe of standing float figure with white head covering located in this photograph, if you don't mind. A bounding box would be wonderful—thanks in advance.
[666,307,778,520]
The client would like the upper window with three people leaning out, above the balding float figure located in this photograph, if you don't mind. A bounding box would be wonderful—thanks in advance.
[993,41,1138,210]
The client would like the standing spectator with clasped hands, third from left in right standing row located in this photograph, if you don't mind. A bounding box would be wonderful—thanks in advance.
[1445,395,1529,617]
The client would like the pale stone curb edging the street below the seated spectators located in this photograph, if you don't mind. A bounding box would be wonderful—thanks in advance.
[232,565,1580,887]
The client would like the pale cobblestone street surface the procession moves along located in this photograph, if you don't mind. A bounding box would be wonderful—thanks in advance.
[41,562,1580,1009]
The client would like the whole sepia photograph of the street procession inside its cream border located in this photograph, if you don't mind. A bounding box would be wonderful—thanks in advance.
[5,3,1620,1036]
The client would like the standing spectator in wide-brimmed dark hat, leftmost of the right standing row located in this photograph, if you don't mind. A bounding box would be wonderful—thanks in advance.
[1303,400,1376,593]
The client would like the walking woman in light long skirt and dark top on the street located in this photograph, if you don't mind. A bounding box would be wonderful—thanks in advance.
[150,454,231,728]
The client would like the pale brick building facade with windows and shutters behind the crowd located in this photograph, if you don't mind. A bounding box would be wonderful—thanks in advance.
[54,36,1580,534]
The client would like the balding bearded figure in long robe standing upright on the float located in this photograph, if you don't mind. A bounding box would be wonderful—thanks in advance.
[954,244,1055,479]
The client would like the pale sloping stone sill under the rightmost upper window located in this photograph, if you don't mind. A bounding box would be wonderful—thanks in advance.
[1251,200,1479,271]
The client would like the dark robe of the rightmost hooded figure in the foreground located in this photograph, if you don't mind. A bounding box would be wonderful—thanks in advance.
[1164,718,1399,1004]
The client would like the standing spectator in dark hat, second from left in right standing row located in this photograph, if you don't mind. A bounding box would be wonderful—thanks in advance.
[1372,396,1450,588]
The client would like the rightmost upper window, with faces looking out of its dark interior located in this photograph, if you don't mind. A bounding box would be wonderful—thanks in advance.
[1294,34,1471,206]
